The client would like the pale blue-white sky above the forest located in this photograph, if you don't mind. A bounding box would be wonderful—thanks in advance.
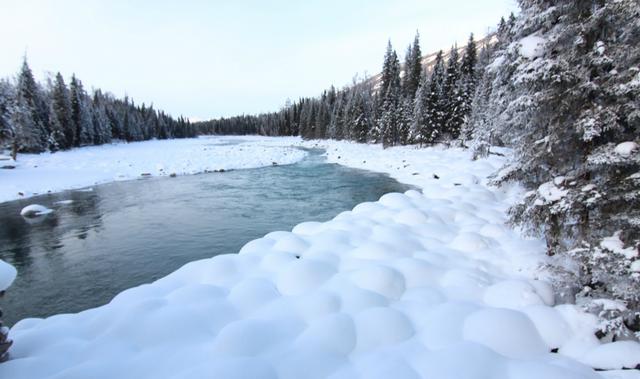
[0,0,517,120]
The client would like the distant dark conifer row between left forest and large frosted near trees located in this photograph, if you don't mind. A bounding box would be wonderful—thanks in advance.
[196,34,478,147]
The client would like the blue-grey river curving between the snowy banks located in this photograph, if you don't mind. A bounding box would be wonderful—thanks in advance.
[0,150,409,325]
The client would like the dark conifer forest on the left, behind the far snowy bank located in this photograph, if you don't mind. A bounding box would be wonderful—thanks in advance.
[0,57,197,159]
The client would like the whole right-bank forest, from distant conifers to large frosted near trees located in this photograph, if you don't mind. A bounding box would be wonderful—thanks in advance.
[198,0,640,338]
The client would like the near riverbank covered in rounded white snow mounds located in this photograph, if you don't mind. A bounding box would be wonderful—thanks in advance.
[0,141,640,379]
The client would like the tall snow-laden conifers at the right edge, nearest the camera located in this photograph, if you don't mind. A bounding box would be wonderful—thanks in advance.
[475,0,640,333]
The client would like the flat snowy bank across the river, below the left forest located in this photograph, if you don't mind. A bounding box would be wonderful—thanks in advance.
[0,136,305,202]
